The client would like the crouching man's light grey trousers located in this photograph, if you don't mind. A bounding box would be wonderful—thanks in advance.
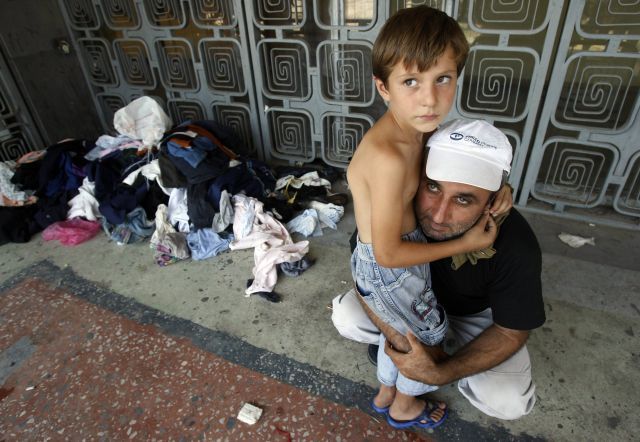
[331,289,536,420]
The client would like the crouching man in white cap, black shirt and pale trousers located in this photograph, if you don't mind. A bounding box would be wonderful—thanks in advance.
[332,122,545,419]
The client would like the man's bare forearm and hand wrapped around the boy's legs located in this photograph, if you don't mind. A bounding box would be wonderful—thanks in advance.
[385,324,529,385]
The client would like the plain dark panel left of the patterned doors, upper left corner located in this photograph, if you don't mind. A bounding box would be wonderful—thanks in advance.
[0,0,104,149]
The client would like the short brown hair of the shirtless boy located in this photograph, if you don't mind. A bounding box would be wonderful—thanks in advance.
[372,6,469,85]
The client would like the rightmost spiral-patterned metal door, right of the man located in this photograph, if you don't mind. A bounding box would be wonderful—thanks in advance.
[518,0,640,228]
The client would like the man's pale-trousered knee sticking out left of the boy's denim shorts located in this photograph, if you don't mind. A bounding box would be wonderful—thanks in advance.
[331,289,380,344]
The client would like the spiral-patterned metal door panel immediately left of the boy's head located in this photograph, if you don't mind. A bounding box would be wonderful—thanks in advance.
[240,0,380,167]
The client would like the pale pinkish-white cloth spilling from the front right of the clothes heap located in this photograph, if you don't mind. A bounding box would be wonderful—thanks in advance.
[229,194,309,296]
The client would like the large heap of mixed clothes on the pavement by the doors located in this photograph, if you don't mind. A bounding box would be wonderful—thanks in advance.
[0,97,347,301]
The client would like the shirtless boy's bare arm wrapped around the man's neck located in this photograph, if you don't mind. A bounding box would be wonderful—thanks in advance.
[366,153,495,267]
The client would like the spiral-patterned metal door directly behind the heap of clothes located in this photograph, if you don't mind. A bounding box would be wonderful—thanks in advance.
[60,0,261,154]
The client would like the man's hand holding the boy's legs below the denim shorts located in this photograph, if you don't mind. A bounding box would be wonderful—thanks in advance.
[384,332,447,385]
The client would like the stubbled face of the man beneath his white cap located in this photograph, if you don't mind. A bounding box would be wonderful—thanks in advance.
[415,176,492,240]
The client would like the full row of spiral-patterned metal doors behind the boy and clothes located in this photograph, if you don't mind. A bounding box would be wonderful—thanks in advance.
[48,0,640,228]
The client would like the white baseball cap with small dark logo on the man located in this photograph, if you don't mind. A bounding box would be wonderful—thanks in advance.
[426,120,513,192]
